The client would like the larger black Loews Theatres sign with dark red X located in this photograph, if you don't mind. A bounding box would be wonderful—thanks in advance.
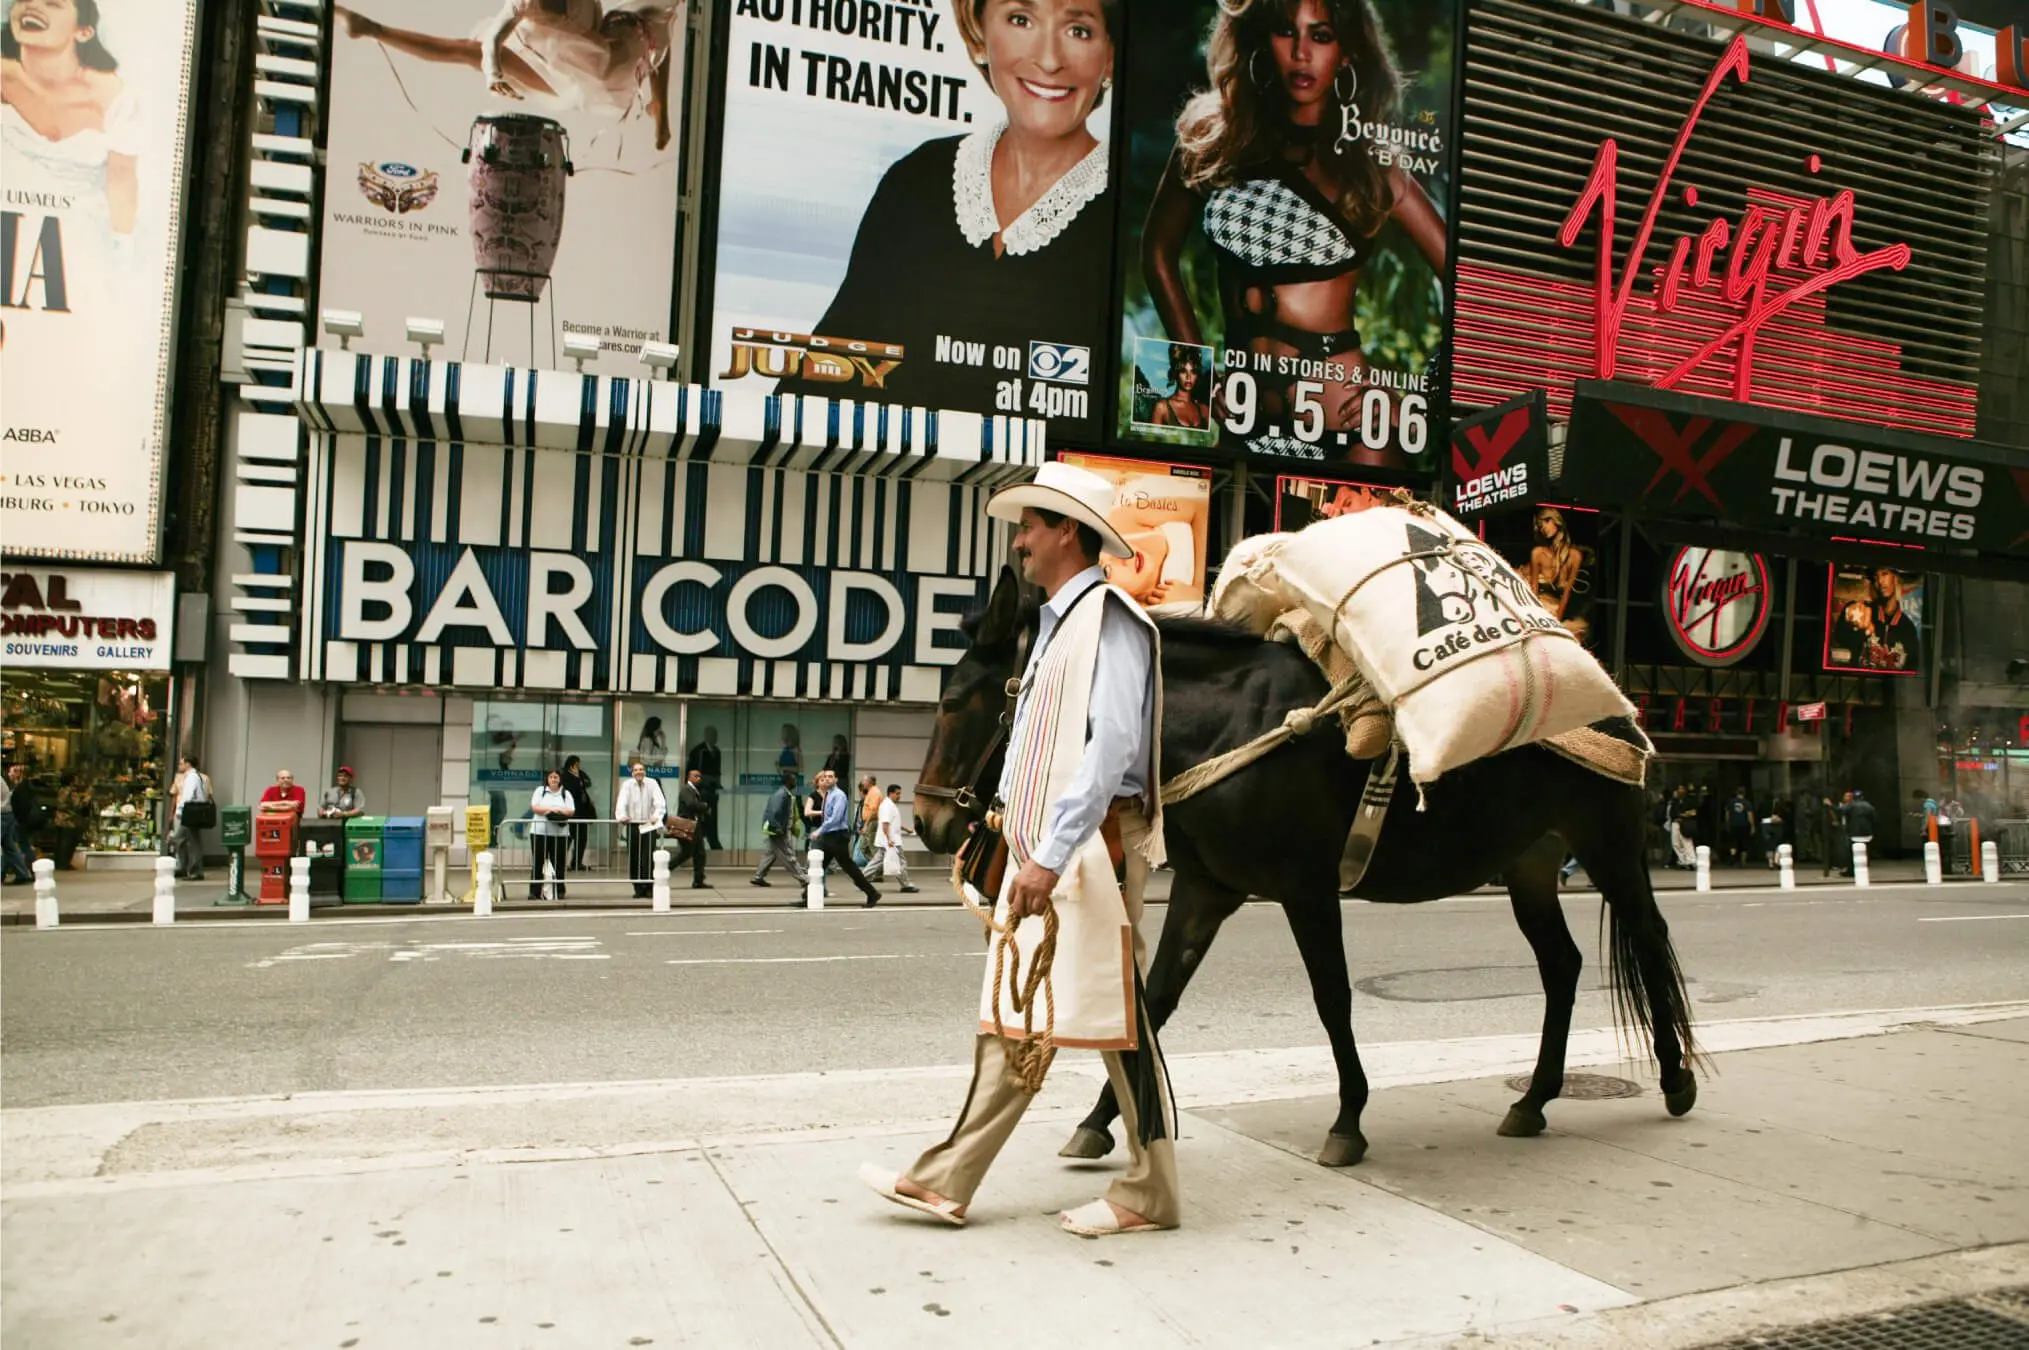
[1562,382,2029,556]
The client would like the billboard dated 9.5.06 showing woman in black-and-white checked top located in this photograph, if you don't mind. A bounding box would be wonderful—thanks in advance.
[1114,0,1457,471]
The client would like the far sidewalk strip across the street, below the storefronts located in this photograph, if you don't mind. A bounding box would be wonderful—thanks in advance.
[0,857,1972,926]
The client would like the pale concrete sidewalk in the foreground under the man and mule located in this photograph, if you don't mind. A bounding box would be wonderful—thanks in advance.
[0,1003,2029,1350]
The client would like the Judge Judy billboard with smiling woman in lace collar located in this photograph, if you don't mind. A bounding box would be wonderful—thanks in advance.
[708,0,1116,445]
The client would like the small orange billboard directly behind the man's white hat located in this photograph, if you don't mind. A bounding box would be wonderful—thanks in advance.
[1061,455,1211,607]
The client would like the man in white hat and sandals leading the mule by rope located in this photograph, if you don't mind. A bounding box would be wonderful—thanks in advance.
[860,463,1181,1236]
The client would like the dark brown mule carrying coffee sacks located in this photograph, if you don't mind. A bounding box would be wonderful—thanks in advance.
[915,570,1698,1167]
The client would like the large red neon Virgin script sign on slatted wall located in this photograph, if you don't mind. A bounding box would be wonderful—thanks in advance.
[1558,37,1909,402]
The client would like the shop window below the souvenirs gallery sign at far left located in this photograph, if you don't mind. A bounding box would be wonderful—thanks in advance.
[0,670,172,867]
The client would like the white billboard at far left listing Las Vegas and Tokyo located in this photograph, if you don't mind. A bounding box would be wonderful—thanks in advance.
[0,0,197,562]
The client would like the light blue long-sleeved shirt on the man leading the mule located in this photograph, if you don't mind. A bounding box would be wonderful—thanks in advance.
[1000,564,1155,873]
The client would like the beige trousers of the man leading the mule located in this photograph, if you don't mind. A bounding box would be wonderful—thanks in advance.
[903,812,1183,1226]
